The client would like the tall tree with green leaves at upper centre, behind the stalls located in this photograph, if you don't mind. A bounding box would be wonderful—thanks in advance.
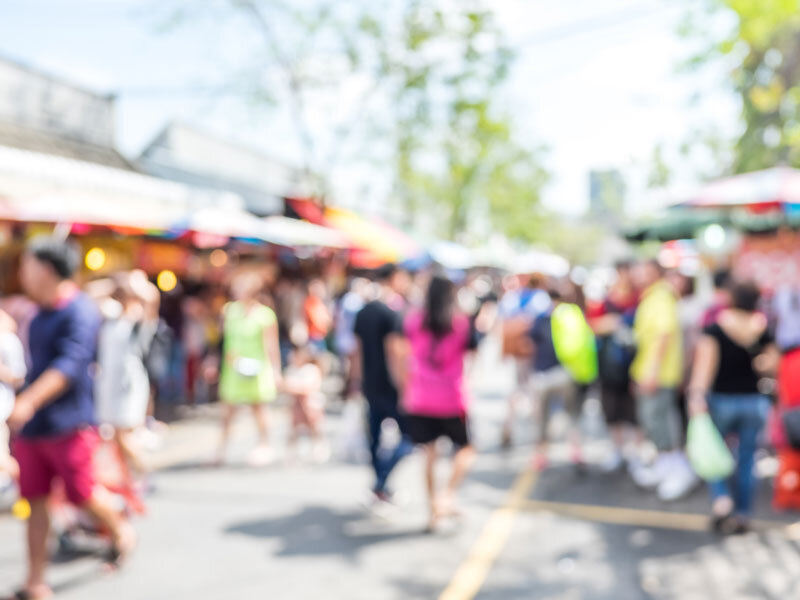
[388,1,547,240]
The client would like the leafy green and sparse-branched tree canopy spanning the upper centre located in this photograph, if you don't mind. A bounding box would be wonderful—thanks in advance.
[162,0,547,238]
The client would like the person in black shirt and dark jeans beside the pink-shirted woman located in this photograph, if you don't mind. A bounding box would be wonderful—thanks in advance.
[353,265,413,502]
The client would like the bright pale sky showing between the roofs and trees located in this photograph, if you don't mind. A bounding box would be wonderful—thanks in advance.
[0,0,737,219]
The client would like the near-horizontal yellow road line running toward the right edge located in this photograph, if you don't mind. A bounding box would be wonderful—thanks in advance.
[520,500,786,531]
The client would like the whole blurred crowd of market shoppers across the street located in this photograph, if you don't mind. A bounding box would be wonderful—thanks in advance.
[0,237,800,597]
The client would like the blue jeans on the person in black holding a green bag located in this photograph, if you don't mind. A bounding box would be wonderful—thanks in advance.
[708,394,769,516]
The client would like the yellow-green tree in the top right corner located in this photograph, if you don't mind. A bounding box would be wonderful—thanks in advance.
[684,0,800,173]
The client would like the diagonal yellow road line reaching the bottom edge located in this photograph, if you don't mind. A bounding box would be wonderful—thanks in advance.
[439,470,537,600]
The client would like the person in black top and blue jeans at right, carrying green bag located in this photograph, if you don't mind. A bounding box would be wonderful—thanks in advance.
[688,283,779,533]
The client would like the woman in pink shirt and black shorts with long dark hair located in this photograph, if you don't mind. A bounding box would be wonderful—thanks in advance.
[403,276,477,531]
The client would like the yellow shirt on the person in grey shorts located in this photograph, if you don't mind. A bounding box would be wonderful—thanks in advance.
[631,281,683,388]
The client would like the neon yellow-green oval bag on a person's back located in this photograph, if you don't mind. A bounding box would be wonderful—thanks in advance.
[550,303,597,384]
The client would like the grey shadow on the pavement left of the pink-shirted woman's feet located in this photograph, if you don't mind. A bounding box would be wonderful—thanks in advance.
[225,506,424,560]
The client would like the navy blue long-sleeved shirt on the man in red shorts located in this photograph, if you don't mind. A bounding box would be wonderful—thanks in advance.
[22,294,100,438]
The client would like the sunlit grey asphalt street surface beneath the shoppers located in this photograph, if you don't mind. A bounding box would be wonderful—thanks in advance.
[0,350,800,600]
